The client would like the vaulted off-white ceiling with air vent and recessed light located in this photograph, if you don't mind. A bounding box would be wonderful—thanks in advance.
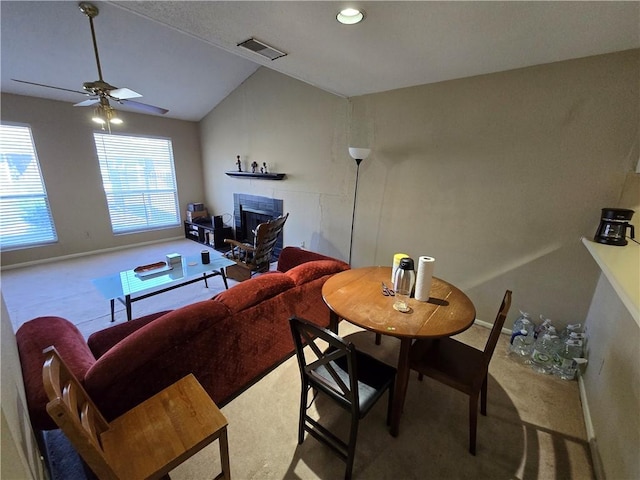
[0,0,640,121]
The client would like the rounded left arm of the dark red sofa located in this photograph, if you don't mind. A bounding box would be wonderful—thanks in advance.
[16,317,96,430]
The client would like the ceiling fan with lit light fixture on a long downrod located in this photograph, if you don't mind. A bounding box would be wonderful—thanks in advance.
[12,2,169,123]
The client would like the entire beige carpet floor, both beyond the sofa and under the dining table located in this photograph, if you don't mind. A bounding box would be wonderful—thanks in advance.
[2,240,594,480]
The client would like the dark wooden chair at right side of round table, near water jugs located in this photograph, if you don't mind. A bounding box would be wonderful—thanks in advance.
[409,290,511,455]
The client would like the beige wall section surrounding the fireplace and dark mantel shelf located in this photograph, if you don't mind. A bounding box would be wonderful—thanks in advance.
[200,68,355,258]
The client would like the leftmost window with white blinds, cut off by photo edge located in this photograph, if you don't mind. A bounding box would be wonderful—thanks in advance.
[0,124,58,250]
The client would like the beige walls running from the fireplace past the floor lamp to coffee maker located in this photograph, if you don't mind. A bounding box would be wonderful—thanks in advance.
[201,50,640,327]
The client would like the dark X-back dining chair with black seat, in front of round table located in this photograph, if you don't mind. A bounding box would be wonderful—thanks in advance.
[289,317,396,479]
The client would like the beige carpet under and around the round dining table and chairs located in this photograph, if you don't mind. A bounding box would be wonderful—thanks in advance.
[171,322,594,480]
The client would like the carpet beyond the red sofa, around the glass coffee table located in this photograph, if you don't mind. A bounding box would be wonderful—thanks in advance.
[2,239,236,337]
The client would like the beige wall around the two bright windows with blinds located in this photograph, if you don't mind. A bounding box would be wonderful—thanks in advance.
[1,93,204,266]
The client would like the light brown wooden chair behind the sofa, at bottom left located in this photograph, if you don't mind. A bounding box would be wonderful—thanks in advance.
[42,347,230,480]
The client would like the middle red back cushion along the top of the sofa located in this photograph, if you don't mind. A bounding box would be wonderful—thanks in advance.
[214,272,295,313]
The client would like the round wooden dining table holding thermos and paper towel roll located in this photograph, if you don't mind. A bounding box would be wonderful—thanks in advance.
[322,267,476,437]
